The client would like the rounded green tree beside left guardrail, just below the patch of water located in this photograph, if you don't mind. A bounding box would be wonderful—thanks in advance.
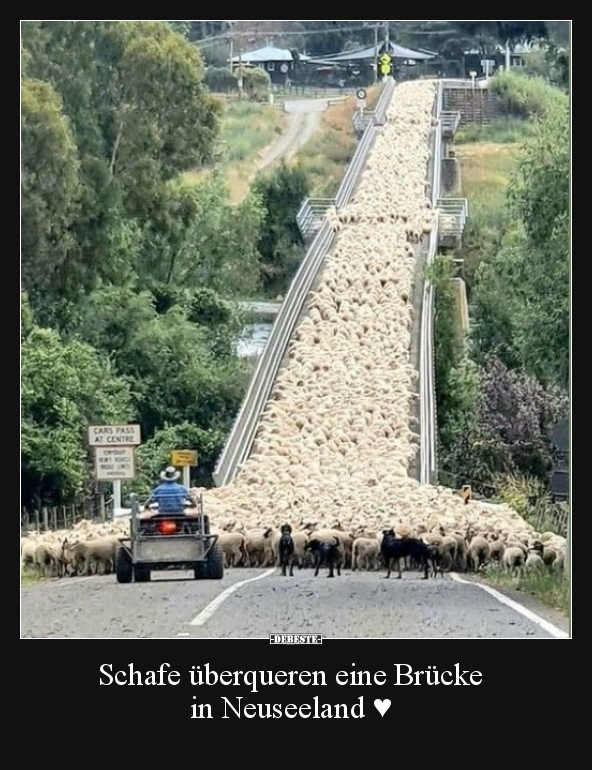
[75,286,249,436]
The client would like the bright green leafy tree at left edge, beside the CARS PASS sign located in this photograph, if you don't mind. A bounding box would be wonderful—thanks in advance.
[21,295,134,506]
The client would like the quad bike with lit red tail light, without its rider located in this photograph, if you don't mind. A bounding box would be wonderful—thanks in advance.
[115,495,224,583]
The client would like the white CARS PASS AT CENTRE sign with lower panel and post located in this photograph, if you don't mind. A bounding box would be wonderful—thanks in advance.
[88,425,141,516]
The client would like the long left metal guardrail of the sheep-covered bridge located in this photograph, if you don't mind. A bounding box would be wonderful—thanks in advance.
[212,81,395,487]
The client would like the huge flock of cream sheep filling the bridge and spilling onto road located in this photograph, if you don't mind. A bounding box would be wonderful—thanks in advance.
[19,81,565,575]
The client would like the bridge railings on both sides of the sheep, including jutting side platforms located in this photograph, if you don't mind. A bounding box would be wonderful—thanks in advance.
[213,80,468,496]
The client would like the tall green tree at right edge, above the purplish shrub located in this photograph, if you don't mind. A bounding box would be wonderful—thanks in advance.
[475,94,571,387]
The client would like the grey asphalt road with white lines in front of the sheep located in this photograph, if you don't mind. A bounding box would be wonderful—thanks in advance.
[21,569,567,639]
